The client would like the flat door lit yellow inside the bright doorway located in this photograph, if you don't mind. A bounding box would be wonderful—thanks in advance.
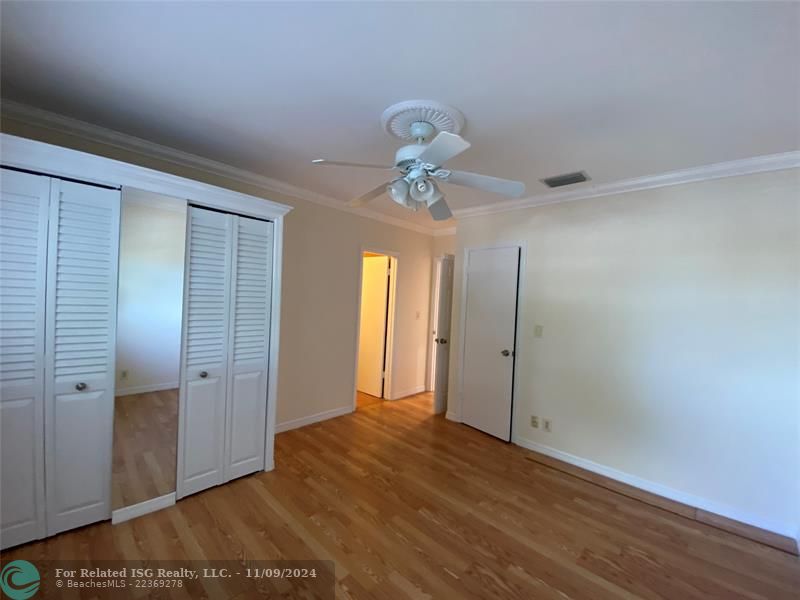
[356,256,389,398]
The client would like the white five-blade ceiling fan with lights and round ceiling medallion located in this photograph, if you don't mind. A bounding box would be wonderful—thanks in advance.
[312,100,525,221]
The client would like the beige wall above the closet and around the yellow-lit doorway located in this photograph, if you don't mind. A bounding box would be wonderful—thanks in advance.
[2,119,433,424]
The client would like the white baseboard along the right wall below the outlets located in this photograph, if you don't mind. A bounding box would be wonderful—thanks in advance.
[511,436,797,538]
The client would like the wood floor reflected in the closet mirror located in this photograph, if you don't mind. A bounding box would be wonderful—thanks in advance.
[111,389,178,509]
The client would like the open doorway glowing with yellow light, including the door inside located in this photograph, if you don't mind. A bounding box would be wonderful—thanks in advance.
[354,250,397,410]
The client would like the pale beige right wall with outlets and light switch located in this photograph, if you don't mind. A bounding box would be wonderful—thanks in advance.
[448,170,800,535]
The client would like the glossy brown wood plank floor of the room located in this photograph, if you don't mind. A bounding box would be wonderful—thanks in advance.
[3,394,800,600]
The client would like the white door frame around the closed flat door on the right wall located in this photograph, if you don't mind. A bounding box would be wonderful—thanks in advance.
[454,240,528,442]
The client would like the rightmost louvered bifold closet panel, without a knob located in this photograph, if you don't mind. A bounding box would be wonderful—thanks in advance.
[224,217,273,481]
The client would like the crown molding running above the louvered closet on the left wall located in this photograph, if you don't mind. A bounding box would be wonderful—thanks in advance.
[0,99,447,235]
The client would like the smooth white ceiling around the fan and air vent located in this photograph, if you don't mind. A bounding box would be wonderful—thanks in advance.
[0,2,800,227]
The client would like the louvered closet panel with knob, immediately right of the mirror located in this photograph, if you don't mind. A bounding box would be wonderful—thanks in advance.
[177,207,235,498]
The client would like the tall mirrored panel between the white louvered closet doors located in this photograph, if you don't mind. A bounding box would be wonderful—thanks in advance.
[112,188,186,510]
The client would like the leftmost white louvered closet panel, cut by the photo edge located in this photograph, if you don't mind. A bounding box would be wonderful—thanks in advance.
[0,169,50,548]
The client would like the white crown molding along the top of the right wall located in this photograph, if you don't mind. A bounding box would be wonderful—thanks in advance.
[453,150,800,219]
